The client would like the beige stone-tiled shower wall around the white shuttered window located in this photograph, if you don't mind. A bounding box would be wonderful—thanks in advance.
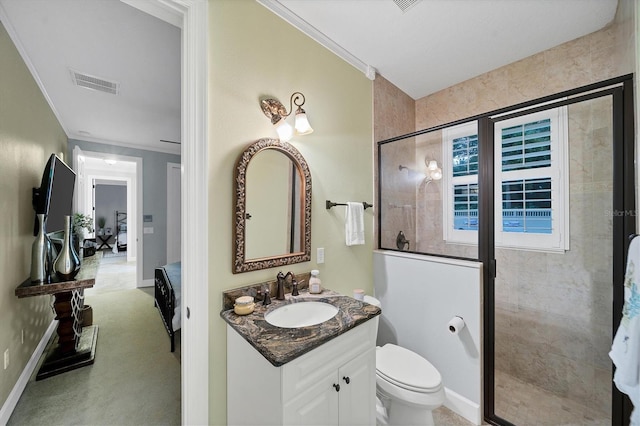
[374,0,636,418]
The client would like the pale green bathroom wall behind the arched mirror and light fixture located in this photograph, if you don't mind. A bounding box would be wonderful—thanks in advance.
[208,0,374,424]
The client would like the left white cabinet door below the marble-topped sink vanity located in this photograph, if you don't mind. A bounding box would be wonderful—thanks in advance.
[284,370,339,426]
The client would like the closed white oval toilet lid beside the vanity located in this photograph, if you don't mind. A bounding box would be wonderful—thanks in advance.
[376,343,442,392]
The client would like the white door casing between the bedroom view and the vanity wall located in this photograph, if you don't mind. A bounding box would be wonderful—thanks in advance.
[125,0,209,425]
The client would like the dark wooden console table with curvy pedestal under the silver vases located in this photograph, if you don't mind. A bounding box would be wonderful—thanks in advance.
[15,252,102,380]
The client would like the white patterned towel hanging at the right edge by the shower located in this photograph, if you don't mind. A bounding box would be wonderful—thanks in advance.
[609,237,640,426]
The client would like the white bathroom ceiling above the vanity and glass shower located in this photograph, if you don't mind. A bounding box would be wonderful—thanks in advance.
[258,0,618,99]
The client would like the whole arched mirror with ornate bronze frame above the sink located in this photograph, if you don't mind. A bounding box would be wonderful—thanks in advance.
[233,139,311,273]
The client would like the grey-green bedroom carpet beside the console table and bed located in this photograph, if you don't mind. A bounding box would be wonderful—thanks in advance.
[8,278,181,425]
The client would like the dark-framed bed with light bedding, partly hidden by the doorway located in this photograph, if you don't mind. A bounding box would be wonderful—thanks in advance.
[154,262,182,352]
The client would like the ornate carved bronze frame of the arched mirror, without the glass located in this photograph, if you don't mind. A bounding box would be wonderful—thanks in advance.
[233,138,311,274]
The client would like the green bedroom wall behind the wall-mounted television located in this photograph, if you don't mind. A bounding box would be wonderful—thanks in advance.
[0,24,68,407]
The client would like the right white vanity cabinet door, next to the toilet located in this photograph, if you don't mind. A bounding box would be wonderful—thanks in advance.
[338,349,376,426]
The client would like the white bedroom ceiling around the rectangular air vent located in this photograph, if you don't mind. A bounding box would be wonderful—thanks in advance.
[0,0,181,153]
